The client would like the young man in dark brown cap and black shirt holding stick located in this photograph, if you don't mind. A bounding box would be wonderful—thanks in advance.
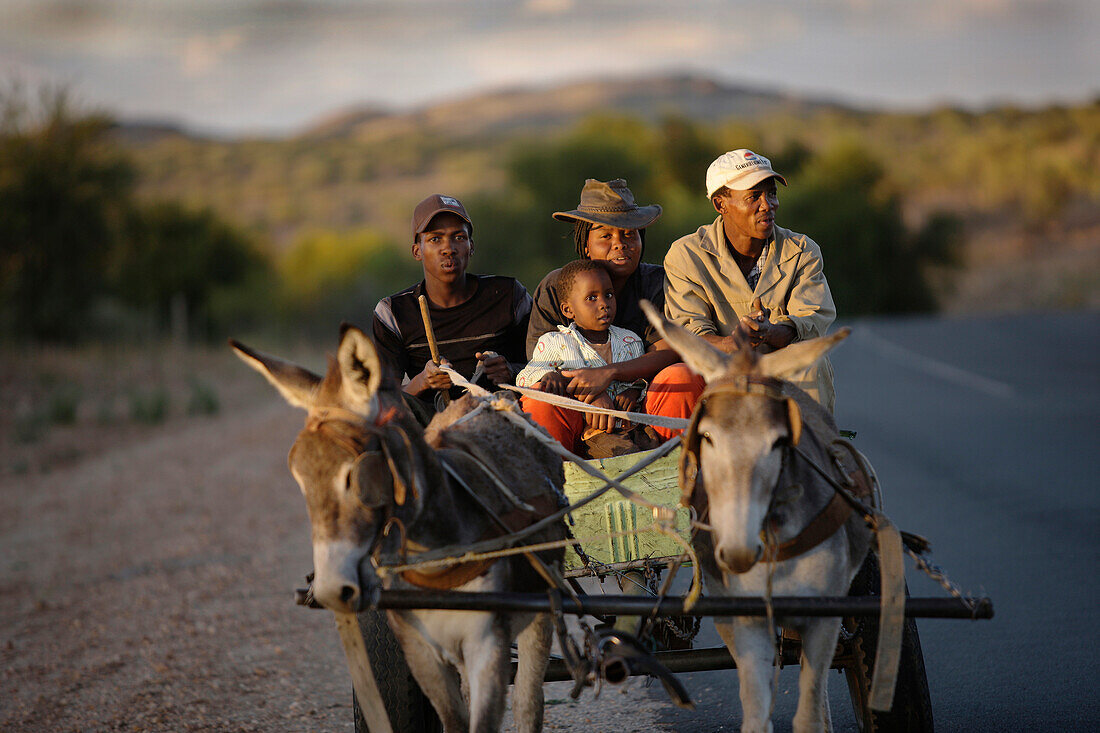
[374,194,531,408]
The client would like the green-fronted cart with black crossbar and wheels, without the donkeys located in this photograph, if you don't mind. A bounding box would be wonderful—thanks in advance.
[298,440,993,733]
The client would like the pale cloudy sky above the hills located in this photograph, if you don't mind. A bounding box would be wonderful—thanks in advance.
[0,0,1100,134]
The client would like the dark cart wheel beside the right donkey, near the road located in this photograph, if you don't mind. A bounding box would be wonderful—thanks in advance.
[844,551,934,733]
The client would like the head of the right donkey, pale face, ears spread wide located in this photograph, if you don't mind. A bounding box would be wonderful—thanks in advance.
[642,303,849,573]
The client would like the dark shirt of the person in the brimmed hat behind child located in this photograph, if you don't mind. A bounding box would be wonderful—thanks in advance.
[527,262,664,359]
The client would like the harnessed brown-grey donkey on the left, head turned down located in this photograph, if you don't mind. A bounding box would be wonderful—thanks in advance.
[232,326,564,732]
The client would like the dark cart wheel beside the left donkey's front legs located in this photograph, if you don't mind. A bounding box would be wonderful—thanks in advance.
[351,611,443,733]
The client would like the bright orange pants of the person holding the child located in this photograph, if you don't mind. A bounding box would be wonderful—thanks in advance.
[520,362,706,453]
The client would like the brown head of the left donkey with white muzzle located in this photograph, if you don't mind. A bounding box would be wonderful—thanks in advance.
[230,326,439,612]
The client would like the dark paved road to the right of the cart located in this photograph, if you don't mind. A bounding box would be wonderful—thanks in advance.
[651,314,1100,733]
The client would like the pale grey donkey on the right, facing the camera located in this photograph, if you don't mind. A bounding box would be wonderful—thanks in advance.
[645,304,870,733]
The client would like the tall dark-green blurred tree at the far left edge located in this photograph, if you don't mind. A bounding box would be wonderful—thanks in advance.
[0,88,134,338]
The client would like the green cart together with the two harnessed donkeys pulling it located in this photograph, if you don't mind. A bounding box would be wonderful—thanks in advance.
[233,323,992,733]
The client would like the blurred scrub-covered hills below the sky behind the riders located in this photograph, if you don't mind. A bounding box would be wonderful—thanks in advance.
[118,75,1100,311]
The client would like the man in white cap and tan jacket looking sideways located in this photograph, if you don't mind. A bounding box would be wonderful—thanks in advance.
[664,149,836,412]
